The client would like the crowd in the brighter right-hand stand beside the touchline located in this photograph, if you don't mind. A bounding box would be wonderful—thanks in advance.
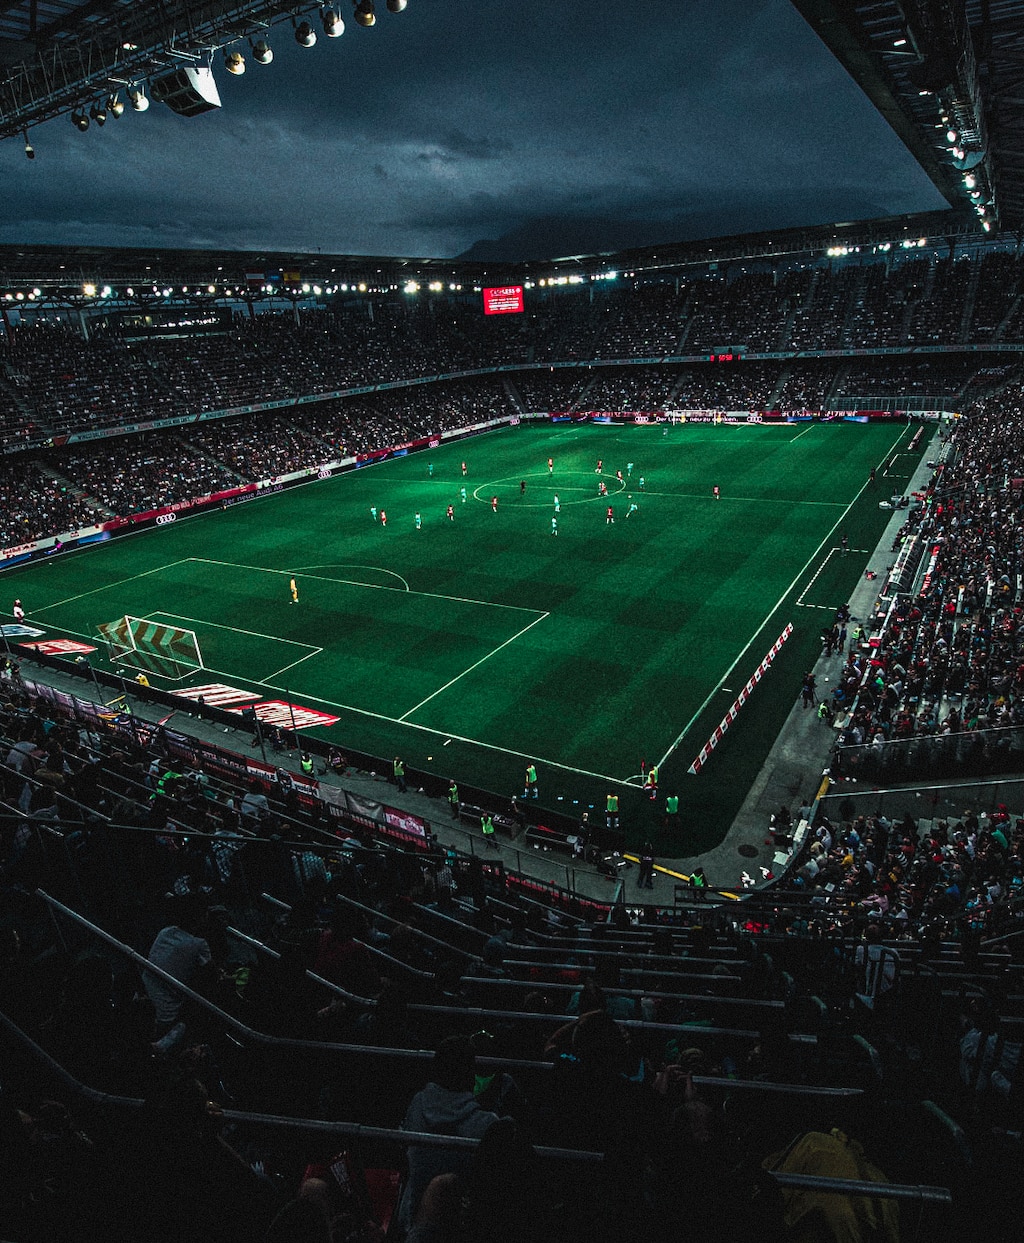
[839,388,1024,785]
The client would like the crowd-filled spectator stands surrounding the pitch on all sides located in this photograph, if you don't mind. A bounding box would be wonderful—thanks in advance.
[0,244,1024,1243]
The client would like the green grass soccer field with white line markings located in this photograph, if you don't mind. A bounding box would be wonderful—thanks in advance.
[7,424,917,854]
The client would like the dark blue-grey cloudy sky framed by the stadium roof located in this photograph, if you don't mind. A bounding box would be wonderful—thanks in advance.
[0,0,944,257]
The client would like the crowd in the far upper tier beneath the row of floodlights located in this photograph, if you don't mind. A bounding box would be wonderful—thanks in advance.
[0,244,1022,440]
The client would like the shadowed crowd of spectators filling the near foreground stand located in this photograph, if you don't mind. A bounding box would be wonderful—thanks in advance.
[0,651,1024,1243]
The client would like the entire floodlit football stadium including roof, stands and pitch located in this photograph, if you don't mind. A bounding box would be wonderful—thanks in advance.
[0,0,1024,1243]
